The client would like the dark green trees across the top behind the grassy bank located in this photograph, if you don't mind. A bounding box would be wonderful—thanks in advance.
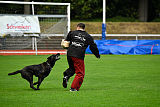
[1,0,160,21]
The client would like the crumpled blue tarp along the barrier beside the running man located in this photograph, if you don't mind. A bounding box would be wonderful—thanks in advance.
[86,40,160,55]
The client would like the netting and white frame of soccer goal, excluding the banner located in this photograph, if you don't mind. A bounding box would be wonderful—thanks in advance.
[0,1,70,50]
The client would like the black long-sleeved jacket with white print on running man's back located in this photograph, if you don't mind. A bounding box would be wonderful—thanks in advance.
[66,30,100,59]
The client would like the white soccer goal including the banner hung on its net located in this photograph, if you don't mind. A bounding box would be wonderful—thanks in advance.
[0,1,70,54]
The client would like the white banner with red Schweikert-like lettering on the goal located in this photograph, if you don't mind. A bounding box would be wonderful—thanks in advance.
[0,16,40,35]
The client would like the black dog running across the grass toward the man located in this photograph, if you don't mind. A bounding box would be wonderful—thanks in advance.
[8,53,60,90]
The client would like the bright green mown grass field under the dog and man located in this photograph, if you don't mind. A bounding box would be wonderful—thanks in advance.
[0,55,160,107]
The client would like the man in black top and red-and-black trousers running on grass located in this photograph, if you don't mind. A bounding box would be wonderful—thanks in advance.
[63,23,100,91]
